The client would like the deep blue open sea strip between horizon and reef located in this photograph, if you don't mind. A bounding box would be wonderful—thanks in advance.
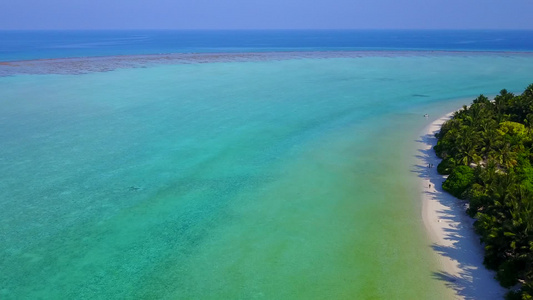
[0,30,533,61]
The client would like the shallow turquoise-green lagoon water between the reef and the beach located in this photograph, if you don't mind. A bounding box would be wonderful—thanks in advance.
[0,54,533,299]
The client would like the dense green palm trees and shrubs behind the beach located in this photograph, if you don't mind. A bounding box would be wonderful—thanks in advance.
[434,84,533,300]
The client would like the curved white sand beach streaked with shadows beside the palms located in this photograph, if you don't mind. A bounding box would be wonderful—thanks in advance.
[417,113,506,299]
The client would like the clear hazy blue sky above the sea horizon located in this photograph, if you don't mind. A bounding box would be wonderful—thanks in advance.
[0,0,533,29]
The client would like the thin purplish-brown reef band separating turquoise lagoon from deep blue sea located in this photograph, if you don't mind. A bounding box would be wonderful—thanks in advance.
[0,51,533,77]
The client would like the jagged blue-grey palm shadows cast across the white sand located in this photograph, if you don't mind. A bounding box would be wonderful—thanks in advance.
[412,129,505,299]
